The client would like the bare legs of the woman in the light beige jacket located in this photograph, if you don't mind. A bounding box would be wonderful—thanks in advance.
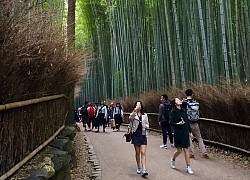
[134,145,147,169]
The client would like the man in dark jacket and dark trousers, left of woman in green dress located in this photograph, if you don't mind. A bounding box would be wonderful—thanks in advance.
[158,94,174,149]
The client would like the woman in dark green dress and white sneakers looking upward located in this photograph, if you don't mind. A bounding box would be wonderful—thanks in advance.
[170,98,193,174]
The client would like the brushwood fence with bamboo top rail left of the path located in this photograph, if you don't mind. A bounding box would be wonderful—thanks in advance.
[0,94,68,176]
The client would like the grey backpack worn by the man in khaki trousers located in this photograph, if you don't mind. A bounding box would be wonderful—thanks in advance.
[187,99,200,122]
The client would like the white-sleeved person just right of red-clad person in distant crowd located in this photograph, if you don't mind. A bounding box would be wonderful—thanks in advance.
[96,101,108,132]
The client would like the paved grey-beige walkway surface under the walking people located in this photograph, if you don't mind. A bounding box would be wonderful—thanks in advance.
[83,127,250,180]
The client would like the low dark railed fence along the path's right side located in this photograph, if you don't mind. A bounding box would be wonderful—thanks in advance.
[124,113,250,154]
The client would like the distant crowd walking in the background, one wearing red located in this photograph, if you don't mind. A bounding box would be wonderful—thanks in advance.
[75,101,123,132]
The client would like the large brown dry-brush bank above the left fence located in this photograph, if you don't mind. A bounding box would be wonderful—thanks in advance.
[0,1,86,103]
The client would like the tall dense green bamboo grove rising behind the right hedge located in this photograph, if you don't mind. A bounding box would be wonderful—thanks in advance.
[74,0,250,102]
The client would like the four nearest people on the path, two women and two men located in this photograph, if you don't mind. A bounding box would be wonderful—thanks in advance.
[128,89,209,177]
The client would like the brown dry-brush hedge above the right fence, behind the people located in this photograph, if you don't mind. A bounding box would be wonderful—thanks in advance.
[117,83,250,125]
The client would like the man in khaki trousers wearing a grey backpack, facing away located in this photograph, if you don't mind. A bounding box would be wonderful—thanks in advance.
[183,89,209,158]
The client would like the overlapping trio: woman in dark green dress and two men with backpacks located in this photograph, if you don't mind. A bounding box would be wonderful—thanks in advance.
[159,89,209,174]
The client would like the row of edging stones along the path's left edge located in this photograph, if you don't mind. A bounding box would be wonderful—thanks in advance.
[83,132,102,180]
